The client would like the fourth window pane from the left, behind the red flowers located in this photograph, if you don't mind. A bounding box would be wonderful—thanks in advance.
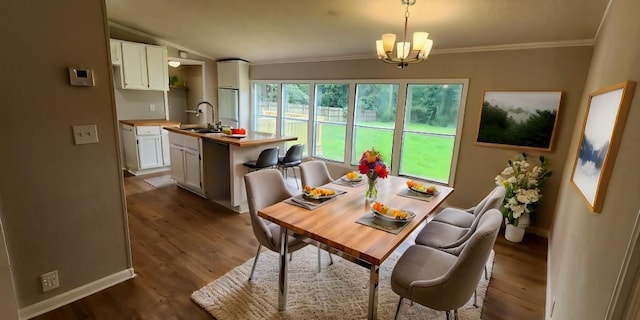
[351,83,399,168]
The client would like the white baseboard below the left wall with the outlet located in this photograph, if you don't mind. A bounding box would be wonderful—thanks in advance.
[18,268,135,319]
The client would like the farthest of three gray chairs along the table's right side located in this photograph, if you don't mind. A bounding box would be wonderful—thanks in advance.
[433,186,506,228]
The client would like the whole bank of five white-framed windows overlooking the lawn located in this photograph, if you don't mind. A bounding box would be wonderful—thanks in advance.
[252,79,468,185]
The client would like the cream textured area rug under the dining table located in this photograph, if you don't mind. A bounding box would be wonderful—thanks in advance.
[191,246,494,320]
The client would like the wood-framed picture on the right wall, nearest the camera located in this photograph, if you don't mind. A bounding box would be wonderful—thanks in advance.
[571,80,636,212]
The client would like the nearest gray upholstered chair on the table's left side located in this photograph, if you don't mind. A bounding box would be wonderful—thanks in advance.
[244,169,333,280]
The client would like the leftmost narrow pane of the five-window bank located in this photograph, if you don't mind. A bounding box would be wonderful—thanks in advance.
[253,83,279,134]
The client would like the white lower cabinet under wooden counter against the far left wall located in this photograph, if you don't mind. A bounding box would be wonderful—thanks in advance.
[120,124,170,175]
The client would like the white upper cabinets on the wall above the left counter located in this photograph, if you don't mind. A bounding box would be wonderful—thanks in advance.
[110,41,169,91]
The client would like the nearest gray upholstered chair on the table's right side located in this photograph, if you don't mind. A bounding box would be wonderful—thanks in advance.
[391,209,502,319]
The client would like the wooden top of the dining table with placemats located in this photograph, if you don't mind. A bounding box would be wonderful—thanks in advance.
[258,176,453,266]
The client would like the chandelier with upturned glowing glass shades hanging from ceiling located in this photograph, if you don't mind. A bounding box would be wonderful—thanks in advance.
[376,0,433,69]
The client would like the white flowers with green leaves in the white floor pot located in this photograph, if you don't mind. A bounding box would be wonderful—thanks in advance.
[495,153,552,226]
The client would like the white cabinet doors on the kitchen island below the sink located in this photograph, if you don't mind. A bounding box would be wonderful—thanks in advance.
[169,132,204,196]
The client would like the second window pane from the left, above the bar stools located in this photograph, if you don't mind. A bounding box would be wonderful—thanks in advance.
[282,83,309,155]
